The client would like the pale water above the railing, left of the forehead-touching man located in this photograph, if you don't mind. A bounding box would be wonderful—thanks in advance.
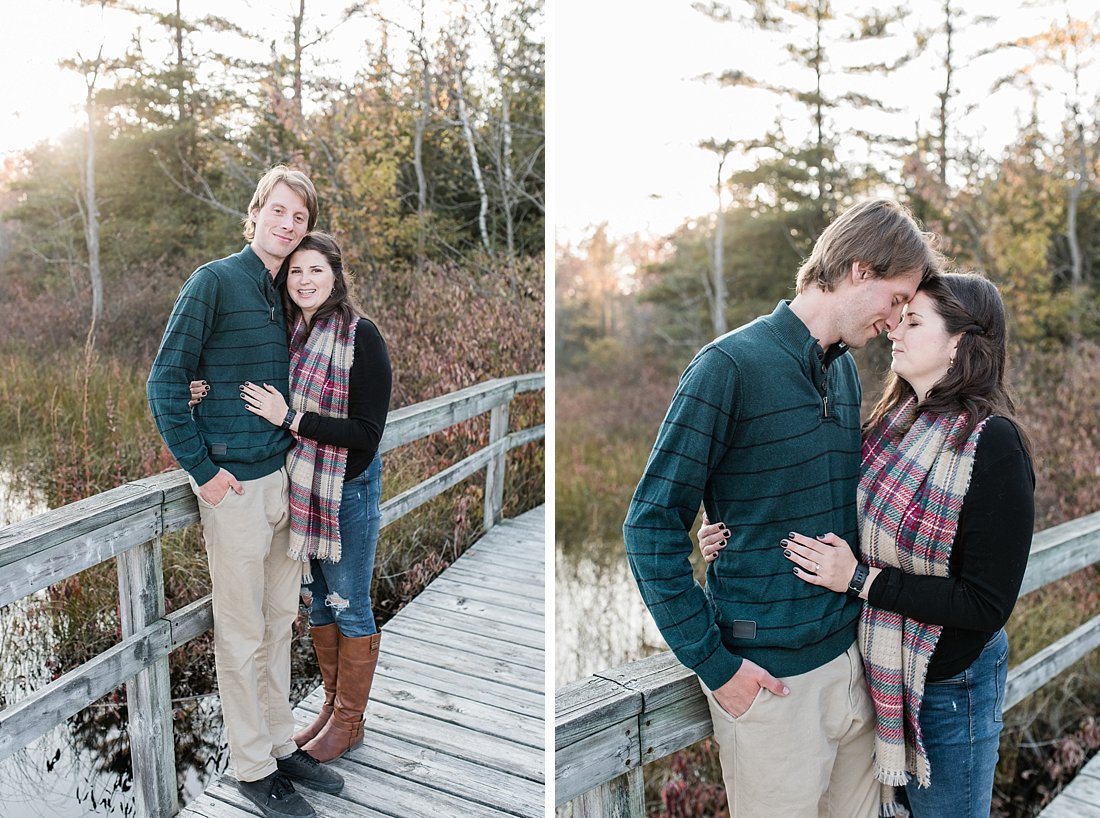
[554,541,668,687]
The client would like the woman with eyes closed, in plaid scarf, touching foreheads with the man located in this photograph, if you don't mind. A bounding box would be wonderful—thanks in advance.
[700,273,1035,818]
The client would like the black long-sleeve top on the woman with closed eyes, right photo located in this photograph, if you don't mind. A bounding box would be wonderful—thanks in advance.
[868,417,1035,682]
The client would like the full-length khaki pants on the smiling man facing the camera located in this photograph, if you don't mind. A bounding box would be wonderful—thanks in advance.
[191,468,301,781]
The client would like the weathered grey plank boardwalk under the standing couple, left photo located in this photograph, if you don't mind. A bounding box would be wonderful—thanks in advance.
[180,506,546,818]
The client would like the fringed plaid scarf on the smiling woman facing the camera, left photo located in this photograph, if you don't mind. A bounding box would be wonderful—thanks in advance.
[286,314,358,583]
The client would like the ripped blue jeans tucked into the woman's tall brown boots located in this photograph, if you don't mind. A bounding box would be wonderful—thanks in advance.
[301,455,382,637]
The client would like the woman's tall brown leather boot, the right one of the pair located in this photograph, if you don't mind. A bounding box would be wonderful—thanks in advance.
[303,631,382,761]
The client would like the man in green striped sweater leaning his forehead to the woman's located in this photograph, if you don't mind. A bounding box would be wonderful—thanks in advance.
[624,200,942,818]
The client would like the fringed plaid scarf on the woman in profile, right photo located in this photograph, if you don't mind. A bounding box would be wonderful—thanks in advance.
[857,397,985,816]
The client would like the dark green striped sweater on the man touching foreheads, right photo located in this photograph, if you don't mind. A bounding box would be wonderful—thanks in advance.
[624,301,861,689]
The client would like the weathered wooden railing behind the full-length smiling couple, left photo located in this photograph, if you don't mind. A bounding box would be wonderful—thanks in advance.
[0,373,545,818]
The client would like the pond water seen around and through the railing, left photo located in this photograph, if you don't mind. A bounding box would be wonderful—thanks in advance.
[0,467,228,818]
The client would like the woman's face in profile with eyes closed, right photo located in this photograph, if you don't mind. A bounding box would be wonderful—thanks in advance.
[887,290,961,400]
